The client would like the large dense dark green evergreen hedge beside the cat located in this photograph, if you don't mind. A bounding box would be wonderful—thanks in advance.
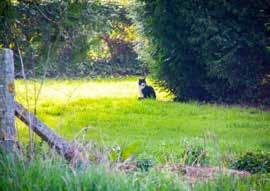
[137,0,270,103]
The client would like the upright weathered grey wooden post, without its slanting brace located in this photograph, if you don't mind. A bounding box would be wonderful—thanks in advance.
[0,49,16,151]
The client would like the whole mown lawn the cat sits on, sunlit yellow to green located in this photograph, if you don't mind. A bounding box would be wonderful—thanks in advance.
[16,78,270,164]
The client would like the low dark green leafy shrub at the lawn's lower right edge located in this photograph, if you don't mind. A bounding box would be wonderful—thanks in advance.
[231,152,270,173]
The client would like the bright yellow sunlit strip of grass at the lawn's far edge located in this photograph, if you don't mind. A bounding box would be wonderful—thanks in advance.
[16,77,173,102]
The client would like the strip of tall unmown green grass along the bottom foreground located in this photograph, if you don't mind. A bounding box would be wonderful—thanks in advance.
[0,150,270,191]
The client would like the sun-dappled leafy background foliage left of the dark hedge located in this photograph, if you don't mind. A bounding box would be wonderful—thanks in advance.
[0,0,146,76]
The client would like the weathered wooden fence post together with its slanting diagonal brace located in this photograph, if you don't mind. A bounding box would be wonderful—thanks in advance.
[0,49,89,164]
